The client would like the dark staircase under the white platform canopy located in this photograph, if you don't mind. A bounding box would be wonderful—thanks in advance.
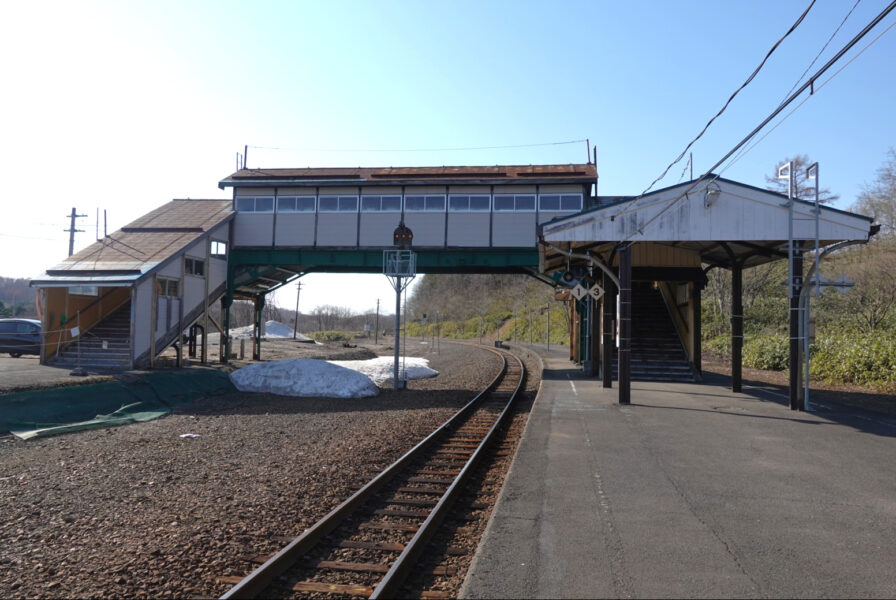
[613,282,695,381]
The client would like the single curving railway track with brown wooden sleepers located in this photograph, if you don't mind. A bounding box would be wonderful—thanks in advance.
[221,348,525,599]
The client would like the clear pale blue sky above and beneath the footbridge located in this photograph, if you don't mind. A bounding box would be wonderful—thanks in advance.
[0,0,896,311]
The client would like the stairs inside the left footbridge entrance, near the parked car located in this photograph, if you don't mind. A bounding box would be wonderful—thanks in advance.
[52,301,131,371]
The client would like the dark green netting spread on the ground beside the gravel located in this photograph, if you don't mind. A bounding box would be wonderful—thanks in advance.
[0,368,235,439]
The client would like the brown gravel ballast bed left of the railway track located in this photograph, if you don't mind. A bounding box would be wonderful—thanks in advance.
[0,342,499,598]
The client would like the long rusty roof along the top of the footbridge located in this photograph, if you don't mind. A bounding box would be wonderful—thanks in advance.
[218,164,597,189]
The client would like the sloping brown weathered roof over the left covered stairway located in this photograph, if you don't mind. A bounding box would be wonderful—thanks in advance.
[36,200,234,277]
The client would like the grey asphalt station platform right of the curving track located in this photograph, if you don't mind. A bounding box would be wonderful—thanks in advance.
[460,347,896,598]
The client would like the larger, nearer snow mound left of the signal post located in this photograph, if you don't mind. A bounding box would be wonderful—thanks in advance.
[230,358,380,398]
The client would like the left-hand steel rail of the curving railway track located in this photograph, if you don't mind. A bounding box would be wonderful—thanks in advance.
[221,348,523,600]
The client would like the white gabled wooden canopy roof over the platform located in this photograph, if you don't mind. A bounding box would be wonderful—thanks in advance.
[540,175,877,272]
